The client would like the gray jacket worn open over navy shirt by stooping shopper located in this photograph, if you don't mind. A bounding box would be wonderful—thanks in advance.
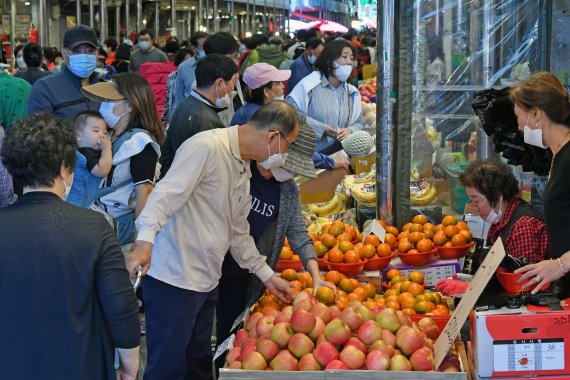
[243,181,317,308]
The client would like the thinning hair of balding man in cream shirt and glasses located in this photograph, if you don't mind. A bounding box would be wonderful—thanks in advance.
[248,100,299,136]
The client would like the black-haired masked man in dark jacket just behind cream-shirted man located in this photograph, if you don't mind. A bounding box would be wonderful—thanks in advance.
[160,54,238,178]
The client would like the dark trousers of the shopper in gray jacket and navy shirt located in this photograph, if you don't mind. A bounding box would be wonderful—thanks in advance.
[216,254,250,371]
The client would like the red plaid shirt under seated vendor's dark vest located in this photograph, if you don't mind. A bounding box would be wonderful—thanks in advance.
[487,197,548,262]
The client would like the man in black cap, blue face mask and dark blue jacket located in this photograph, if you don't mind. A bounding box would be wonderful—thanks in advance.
[28,25,100,121]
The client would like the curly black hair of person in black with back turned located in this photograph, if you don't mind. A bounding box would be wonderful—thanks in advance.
[1,113,77,188]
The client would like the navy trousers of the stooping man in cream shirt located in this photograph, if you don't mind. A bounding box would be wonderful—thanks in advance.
[142,276,218,380]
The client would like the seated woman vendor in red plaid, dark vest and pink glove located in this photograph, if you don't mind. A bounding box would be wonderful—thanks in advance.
[437,159,548,295]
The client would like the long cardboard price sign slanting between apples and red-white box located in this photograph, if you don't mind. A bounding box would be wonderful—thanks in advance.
[434,238,506,368]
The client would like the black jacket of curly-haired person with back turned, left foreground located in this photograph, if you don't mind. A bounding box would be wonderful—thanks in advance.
[0,192,140,380]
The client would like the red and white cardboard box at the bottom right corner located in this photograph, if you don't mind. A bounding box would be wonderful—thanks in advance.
[470,308,570,379]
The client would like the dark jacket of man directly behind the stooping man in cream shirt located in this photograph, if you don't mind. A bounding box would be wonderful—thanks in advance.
[160,91,225,178]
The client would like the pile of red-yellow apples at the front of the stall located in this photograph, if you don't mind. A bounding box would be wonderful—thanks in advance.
[226,292,460,372]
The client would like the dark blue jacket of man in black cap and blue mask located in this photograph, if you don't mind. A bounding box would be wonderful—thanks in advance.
[28,65,101,121]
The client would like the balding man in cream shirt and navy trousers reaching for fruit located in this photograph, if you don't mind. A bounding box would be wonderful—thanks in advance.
[128,101,299,380]
